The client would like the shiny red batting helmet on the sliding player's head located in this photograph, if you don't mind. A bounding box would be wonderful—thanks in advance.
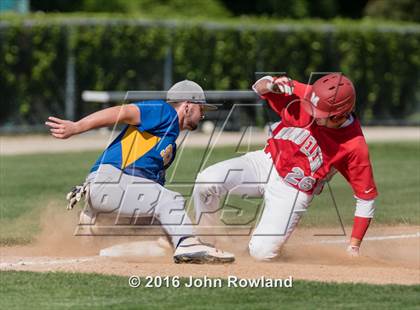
[302,73,356,118]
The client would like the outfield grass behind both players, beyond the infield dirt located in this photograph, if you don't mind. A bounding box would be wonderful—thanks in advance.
[0,143,420,244]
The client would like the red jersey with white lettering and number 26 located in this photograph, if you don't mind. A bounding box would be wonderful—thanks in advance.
[262,81,378,200]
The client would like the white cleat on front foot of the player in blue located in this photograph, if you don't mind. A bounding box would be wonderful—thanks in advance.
[174,237,235,264]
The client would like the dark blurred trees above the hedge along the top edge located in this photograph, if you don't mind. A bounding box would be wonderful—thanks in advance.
[30,0,420,22]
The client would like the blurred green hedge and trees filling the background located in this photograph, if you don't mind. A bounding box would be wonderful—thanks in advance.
[0,0,420,127]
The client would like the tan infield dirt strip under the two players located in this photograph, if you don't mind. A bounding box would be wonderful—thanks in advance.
[0,210,420,284]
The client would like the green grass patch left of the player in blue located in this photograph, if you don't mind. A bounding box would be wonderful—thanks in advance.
[0,153,97,244]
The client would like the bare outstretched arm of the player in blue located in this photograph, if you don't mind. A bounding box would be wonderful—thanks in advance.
[45,104,140,139]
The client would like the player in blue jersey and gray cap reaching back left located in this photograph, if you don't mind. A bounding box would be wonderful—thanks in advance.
[45,80,234,263]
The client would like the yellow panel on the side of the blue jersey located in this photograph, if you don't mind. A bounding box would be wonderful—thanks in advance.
[121,126,160,169]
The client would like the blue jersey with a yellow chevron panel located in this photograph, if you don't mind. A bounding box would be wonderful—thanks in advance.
[91,100,179,185]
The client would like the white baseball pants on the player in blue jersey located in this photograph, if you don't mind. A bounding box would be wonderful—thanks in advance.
[82,164,193,247]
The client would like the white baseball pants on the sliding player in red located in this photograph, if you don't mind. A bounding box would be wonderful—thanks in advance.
[193,150,312,260]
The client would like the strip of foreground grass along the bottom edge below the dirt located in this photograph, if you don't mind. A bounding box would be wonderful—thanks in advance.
[0,271,420,310]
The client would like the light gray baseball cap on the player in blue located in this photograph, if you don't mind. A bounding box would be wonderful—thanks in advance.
[166,80,217,111]
